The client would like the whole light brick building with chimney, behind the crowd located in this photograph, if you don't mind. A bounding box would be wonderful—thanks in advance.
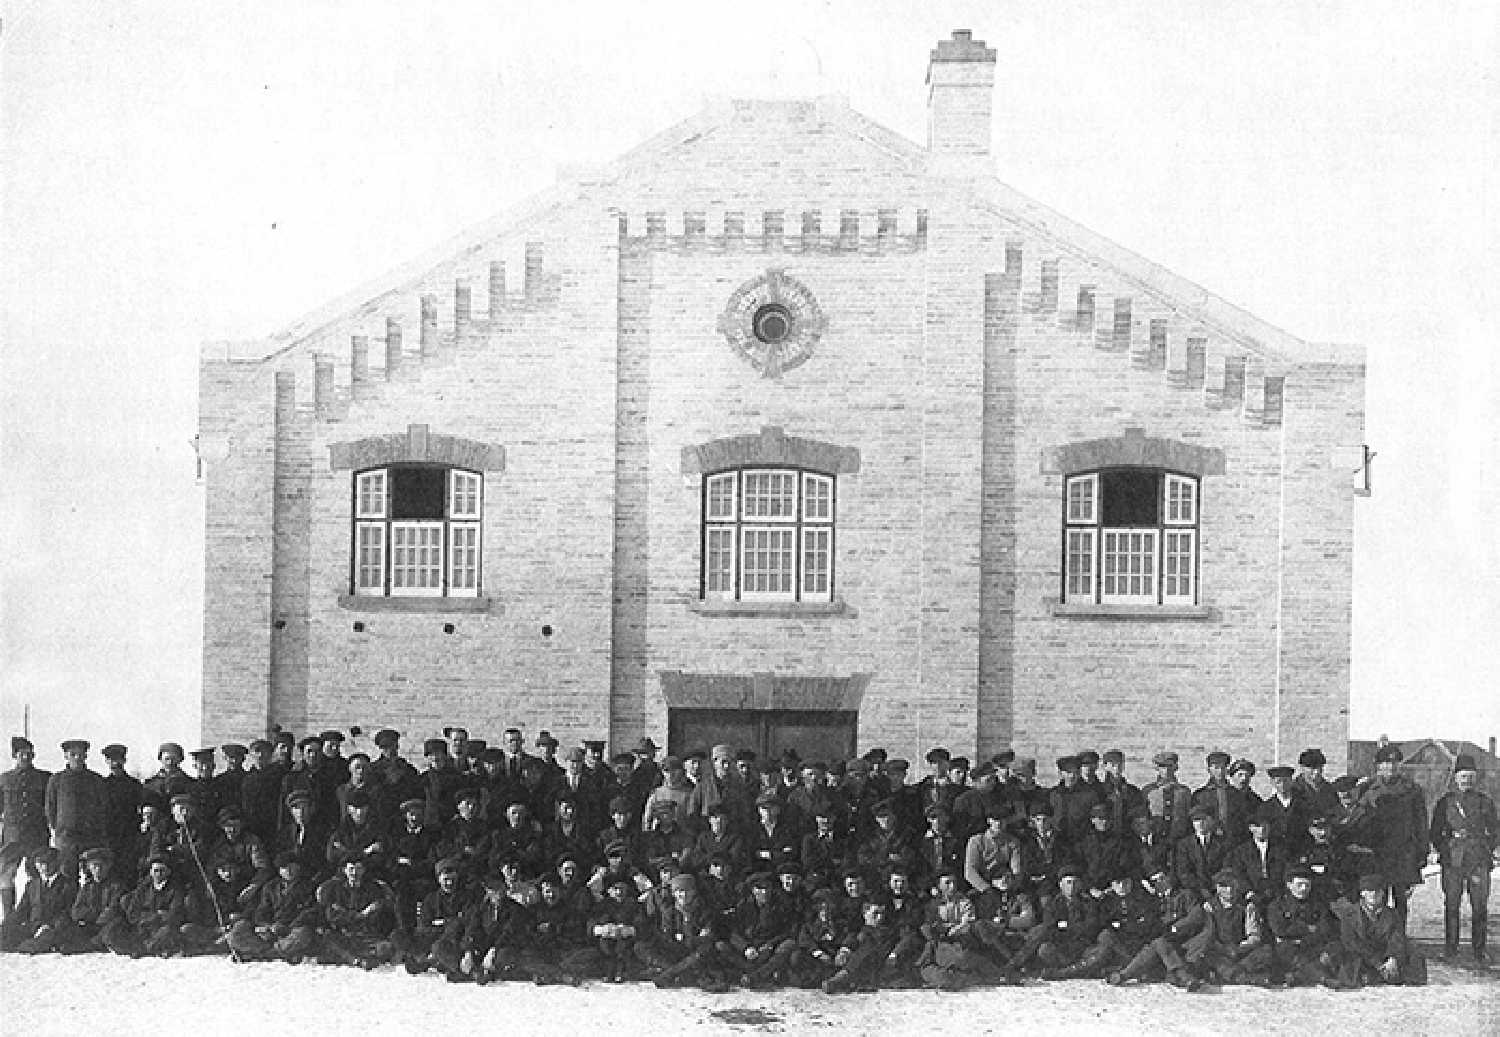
[201,33,1364,770]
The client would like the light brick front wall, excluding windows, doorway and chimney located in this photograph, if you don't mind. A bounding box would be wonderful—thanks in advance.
[203,104,1362,774]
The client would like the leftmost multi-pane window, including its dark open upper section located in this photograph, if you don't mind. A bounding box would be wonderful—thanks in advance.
[353,465,485,597]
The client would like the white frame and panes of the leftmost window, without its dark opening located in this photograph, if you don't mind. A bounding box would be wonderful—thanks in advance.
[350,465,485,597]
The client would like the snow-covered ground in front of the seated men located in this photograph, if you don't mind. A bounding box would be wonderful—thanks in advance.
[0,875,1500,1037]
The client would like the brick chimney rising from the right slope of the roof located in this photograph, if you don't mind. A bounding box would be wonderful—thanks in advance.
[927,29,995,168]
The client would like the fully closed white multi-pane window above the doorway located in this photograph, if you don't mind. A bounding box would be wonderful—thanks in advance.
[702,468,834,602]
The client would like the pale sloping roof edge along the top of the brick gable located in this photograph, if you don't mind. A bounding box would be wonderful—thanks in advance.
[222,96,1364,365]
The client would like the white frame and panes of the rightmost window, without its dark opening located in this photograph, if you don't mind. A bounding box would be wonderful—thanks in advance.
[1062,468,1202,606]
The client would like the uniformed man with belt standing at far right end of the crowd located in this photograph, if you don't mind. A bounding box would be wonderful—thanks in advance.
[1428,752,1500,966]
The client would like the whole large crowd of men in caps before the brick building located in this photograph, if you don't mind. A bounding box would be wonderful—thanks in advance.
[0,726,1500,993]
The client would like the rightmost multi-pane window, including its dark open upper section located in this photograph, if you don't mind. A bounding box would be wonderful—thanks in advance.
[1062,468,1199,605]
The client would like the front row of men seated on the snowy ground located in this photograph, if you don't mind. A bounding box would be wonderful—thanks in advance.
[0,828,1425,993]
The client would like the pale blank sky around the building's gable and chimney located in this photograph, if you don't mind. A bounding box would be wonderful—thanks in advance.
[0,0,1500,764]
